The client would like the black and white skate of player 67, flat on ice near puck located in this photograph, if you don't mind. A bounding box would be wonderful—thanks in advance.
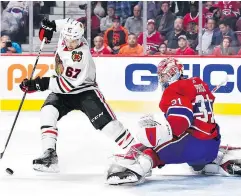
[33,148,59,173]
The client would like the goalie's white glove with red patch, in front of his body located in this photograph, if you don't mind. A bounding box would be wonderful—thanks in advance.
[136,121,173,148]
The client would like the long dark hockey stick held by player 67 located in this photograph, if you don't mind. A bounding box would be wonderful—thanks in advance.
[0,38,45,159]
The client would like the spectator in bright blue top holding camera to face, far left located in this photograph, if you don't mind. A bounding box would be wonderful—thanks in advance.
[0,35,22,53]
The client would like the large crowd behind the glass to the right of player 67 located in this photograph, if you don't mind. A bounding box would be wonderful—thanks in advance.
[86,1,241,55]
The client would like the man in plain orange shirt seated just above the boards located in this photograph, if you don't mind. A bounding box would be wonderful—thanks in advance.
[119,34,143,55]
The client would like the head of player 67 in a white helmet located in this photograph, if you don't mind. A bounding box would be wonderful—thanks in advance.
[62,21,84,51]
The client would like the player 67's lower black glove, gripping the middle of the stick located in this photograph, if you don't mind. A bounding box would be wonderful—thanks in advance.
[19,77,50,93]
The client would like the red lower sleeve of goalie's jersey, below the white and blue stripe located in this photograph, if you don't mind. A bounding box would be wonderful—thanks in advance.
[167,116,189,136]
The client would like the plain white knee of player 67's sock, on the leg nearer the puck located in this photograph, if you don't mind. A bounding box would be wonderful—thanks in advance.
[40,105,59,127]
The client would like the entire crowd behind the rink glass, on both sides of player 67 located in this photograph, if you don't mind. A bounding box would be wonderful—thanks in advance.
[1,1,241,55]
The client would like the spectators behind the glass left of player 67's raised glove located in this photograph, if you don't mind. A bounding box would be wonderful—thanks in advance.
[0,1,55,53]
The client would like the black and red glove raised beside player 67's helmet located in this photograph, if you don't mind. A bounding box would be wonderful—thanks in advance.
[39,18,56,44]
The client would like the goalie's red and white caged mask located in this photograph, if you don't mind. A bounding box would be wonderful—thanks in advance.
[157,58,183,90]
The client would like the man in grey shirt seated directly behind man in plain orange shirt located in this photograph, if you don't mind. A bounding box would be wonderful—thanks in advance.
[125,5,143,36]
